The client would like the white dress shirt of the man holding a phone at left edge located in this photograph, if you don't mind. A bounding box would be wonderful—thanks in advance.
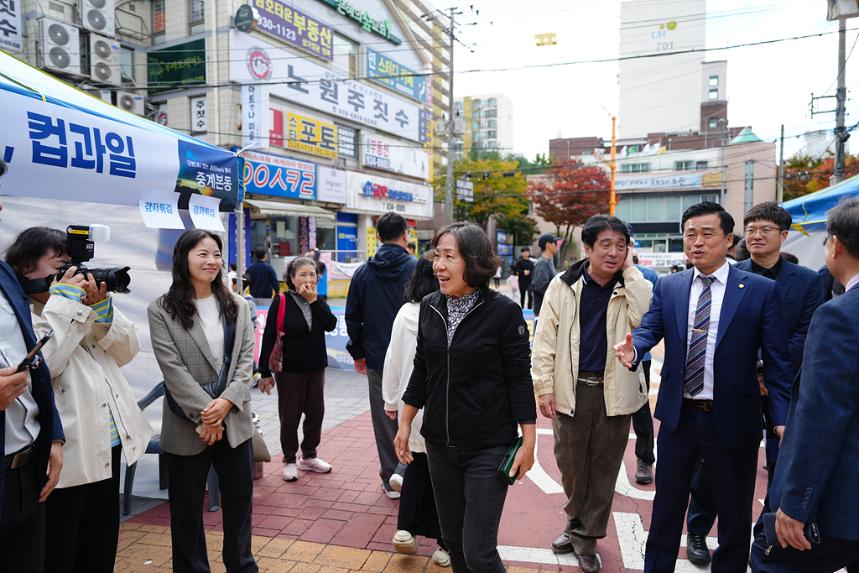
[0,293,41,456]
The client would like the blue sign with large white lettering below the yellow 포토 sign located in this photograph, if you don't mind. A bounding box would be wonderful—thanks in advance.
[242,150,316,200]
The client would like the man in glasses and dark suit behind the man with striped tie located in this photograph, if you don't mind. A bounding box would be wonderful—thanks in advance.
[686,201,823,564]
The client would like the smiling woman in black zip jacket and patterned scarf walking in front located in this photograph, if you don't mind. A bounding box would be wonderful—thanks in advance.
[394,223,537,573]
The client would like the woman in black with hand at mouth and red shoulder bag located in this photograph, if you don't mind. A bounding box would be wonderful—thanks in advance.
[259,257,337,481]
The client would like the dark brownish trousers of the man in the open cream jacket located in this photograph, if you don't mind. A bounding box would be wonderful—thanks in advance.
[552,383,630,555]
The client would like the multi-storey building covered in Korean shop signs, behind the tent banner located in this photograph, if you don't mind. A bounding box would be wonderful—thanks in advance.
[2,0,450,278]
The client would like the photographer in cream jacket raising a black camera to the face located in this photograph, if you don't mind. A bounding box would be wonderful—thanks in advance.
[6,227,152,573]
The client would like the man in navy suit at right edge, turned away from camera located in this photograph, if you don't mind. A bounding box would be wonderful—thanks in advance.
[751,199,859,573]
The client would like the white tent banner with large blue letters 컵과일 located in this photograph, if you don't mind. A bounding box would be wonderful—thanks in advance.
[0,52,242,211]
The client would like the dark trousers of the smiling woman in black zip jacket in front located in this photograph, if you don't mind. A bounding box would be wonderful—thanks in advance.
[427,443,508,573]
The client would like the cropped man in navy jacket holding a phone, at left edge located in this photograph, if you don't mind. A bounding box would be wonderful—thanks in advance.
[0,199,64,573]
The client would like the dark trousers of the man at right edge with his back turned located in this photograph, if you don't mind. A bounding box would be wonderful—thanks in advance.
[749,533,859,573]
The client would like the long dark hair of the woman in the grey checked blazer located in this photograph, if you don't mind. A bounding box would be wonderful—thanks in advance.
[159,229,238,330]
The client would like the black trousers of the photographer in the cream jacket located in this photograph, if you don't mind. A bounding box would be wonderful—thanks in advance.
[45,446,122,573]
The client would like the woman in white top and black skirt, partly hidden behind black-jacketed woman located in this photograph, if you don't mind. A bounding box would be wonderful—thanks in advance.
[382,257,450,567]
